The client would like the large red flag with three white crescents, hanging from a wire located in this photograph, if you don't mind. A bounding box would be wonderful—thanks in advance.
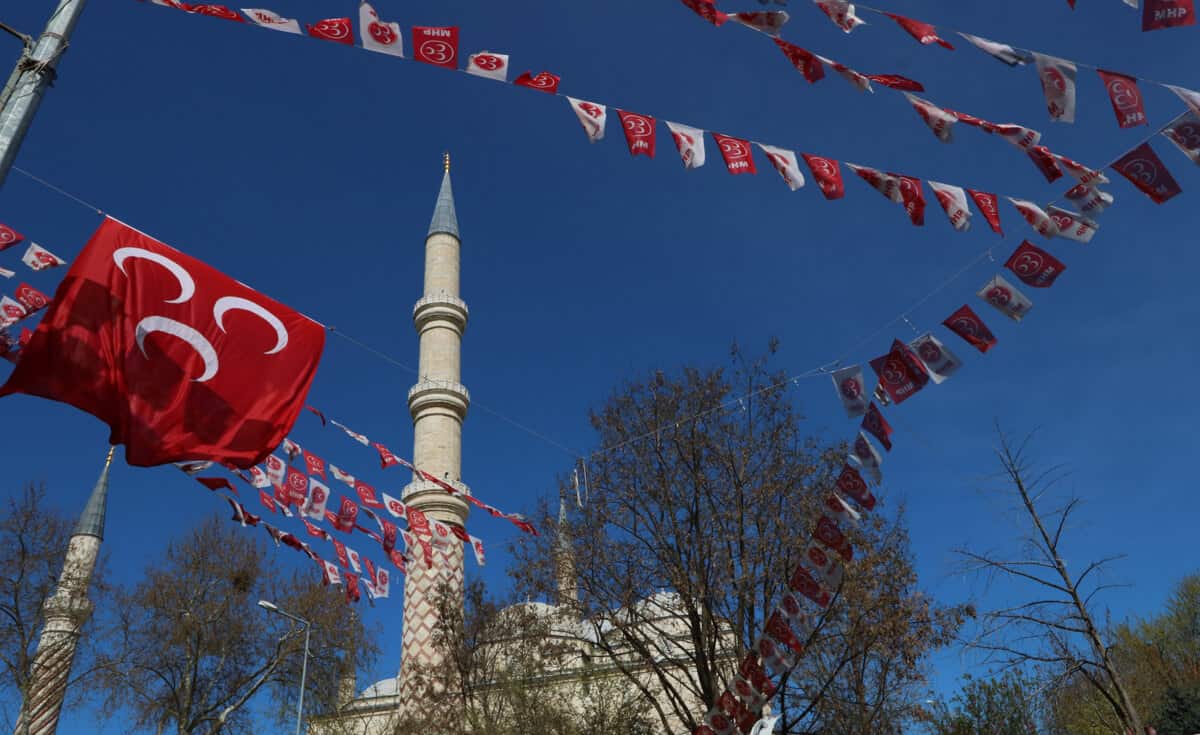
[0,220,325,467]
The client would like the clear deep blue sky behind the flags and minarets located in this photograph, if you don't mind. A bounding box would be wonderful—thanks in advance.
[0,0,1200,733]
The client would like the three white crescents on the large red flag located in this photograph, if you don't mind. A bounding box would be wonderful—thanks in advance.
[113,247,288,383]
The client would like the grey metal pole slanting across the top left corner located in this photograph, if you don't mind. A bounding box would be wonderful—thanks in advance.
[0,0,86,186]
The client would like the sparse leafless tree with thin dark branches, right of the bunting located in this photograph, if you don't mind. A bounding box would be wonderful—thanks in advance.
[958,429,1141,733]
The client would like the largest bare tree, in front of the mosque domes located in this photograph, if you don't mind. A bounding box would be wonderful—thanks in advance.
[515,346,962,733]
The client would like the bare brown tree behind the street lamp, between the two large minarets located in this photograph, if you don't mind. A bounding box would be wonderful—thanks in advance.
[101,519,376,735]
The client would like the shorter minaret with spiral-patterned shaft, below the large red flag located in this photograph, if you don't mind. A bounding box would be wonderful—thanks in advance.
[13,448,113,735]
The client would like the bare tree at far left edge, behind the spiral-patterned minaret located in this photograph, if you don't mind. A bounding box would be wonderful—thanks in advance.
[0,484,106,728]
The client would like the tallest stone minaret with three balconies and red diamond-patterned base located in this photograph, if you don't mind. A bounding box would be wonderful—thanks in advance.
[400,154,470,707]
